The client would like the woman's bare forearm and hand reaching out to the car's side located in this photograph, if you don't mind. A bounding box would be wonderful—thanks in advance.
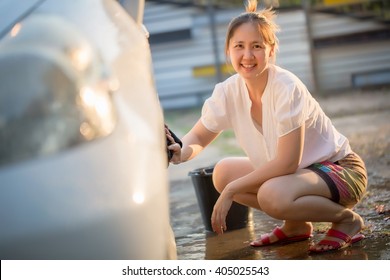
[168,119,219,164]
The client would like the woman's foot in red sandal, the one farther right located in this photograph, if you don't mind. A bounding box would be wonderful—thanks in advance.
[309,212,364,253]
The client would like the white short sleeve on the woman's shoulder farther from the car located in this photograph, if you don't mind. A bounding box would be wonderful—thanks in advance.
[275,83,309,137]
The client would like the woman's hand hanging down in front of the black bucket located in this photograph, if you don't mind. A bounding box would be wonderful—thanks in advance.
[211,186,233,234]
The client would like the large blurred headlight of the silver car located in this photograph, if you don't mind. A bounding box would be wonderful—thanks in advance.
[0,15,118,165]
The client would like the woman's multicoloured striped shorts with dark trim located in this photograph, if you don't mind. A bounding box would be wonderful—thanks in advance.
[306,153,368,207]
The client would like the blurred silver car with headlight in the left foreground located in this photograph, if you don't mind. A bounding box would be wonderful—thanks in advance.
[0,0,176,260]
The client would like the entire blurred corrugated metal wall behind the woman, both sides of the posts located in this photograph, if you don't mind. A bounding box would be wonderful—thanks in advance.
[144,2,390,109]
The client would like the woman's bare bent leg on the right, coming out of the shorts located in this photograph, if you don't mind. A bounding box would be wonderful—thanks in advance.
[257,169,363,250]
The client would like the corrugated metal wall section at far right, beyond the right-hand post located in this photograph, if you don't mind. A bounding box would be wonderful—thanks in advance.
[312,13,390,93]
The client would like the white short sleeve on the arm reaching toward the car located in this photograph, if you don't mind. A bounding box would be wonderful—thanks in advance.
[201,84,230,133]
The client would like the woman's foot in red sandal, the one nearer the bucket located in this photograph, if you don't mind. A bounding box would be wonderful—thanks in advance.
[250,221,313,247]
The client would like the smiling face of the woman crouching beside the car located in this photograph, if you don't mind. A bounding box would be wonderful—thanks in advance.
[227,22,274,79]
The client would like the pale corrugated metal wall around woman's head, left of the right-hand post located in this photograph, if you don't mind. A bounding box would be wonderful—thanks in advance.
[144,2,313,109]
